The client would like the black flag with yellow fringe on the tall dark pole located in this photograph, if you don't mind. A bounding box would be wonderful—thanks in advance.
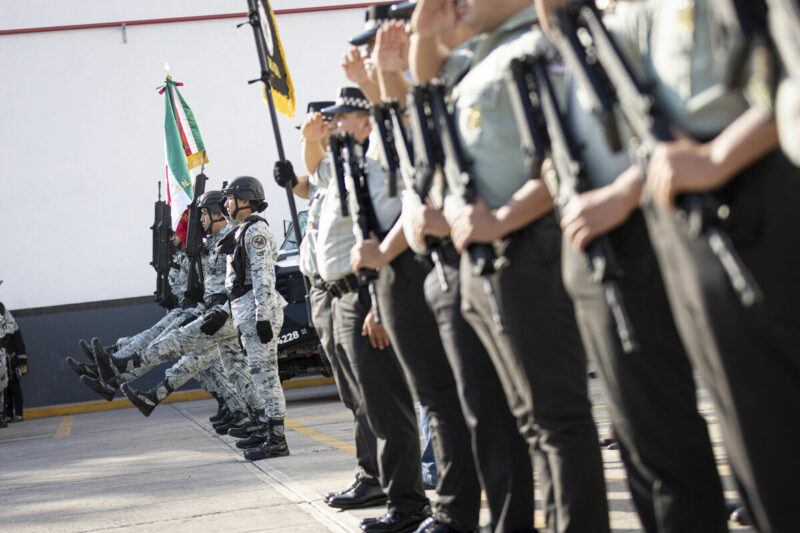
[251,0,295,118]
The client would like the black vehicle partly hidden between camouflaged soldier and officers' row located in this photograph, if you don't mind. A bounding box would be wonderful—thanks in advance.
[275,211,332,381]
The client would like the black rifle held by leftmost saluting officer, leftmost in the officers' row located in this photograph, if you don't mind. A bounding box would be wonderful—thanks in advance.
[330,133,381,324]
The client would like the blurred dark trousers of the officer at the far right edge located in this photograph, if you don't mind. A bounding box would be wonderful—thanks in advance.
[645,152,800,532]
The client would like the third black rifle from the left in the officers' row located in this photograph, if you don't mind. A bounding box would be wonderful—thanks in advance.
[428,82,505,332]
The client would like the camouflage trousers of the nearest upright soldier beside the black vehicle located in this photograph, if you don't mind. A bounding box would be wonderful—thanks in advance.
[231,291,286,418]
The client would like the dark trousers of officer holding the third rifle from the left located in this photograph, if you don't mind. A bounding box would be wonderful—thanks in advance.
[461,214,608,533]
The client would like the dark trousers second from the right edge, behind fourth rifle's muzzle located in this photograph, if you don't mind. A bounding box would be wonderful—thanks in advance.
[563,211,728,533]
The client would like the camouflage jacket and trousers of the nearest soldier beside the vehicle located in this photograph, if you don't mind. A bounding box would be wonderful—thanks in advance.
[225,215,287,419]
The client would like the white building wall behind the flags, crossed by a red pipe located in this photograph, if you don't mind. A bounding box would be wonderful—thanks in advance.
[0,0,363,309]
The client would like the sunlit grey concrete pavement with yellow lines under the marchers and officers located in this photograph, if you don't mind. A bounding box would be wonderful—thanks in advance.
[0,380,750,533]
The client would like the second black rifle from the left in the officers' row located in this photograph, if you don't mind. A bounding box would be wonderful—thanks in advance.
[372,100,449,292]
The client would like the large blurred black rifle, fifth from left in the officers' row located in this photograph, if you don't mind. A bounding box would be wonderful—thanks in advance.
[555,2,763,307]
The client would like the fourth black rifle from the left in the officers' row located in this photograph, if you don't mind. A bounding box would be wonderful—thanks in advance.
[507,56,639,353]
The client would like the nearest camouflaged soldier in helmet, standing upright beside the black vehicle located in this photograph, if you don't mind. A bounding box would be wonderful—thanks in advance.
[220,176,289,461]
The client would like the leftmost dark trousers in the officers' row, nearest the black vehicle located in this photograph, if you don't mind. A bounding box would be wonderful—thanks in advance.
[308,286,379,485]
